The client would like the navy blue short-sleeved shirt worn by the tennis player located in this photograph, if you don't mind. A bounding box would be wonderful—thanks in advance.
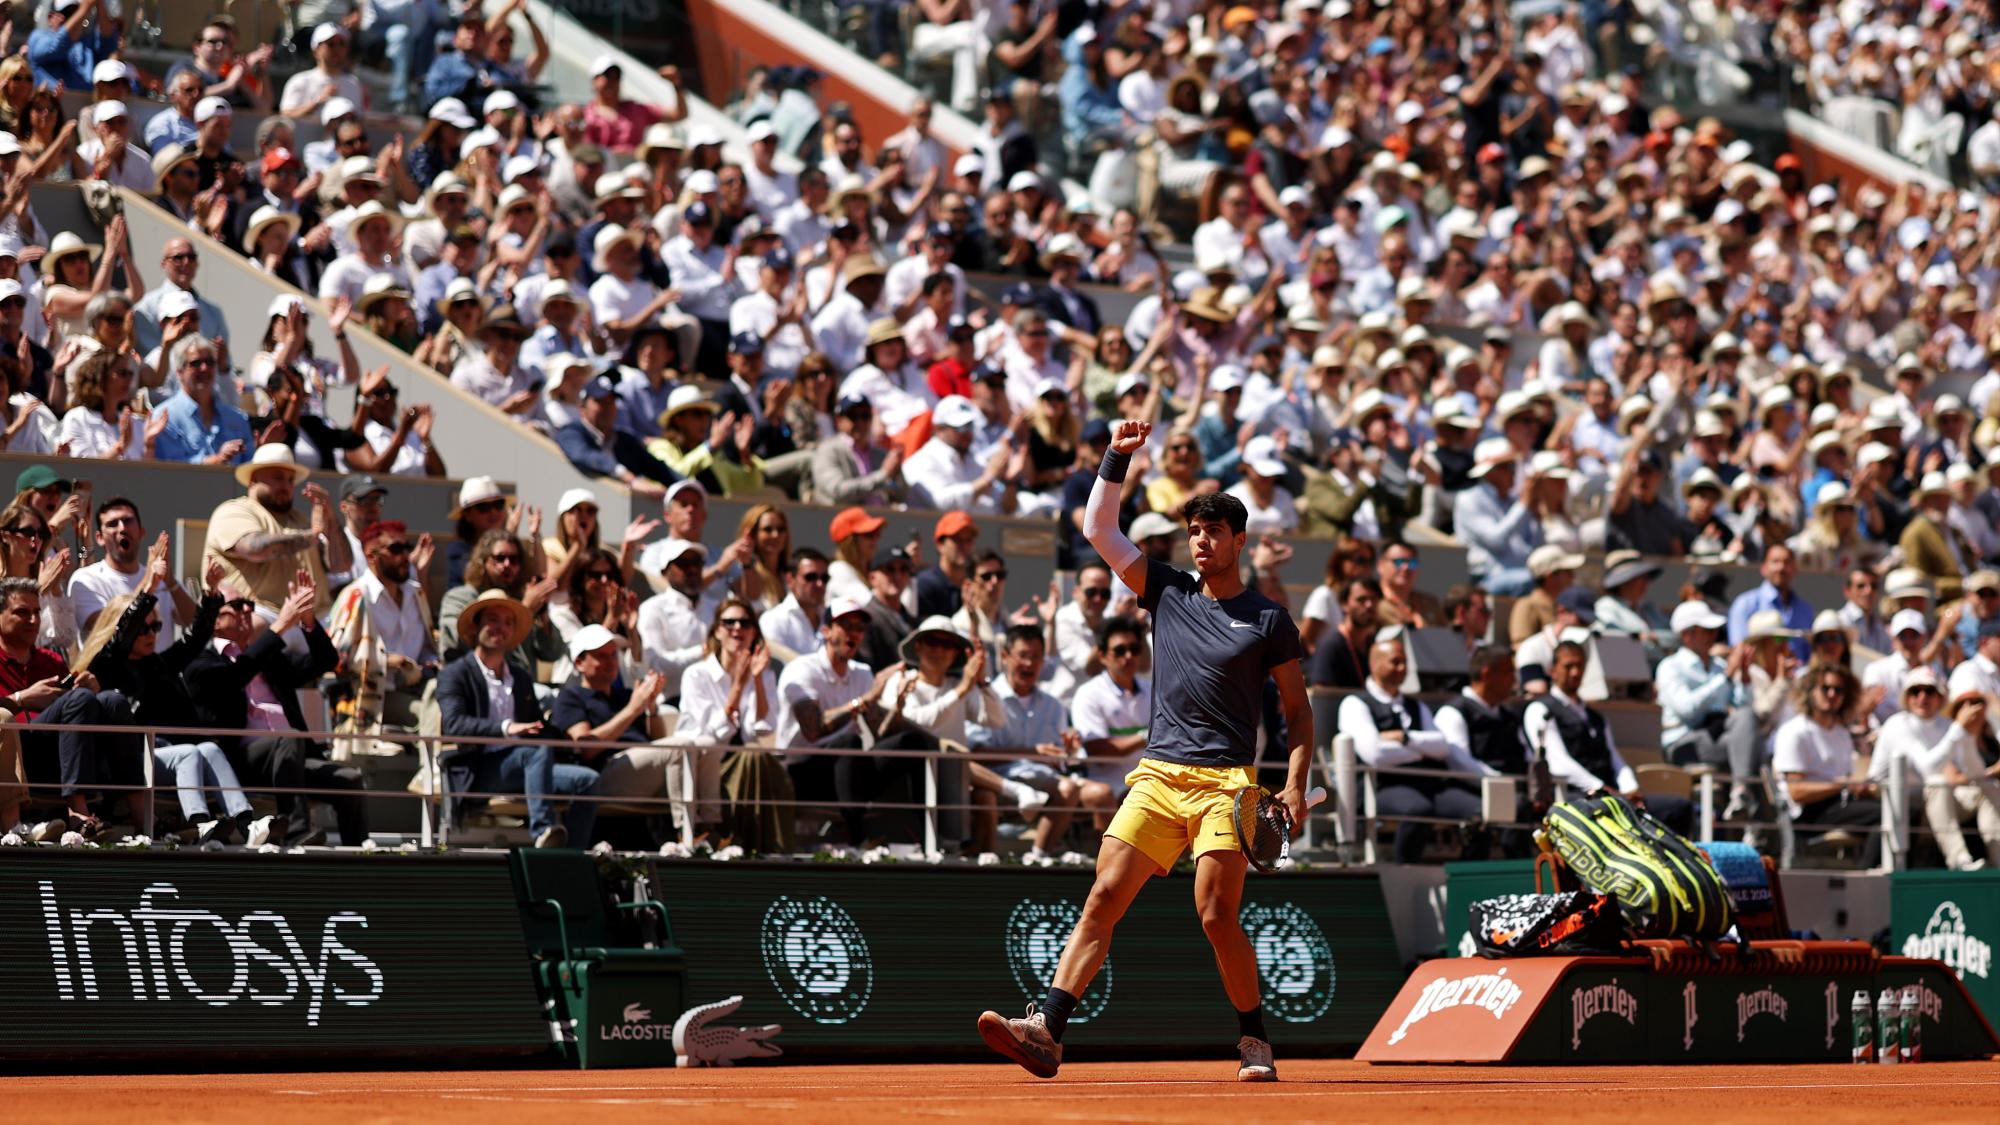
[1140,558,1304,767]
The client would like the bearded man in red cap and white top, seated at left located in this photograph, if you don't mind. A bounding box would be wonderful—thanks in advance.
[328,520,440,733]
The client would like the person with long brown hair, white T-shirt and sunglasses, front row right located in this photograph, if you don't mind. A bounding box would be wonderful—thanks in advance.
[1772,665,1882,867]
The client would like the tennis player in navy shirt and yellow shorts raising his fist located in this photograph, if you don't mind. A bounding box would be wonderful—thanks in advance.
[980,420,1312,1083]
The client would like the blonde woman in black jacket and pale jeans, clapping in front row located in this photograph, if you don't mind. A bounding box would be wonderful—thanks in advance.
[76,544,274,847]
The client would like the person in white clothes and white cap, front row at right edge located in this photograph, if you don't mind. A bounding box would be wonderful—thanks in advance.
[1868,669,2000,871]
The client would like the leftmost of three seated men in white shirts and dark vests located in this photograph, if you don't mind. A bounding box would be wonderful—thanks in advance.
[1338,636,1498,863]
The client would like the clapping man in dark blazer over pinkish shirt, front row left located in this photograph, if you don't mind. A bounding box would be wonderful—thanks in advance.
[182,571,368,847]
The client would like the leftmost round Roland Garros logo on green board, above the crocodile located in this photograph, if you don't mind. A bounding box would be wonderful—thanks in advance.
[760,895,874,1023]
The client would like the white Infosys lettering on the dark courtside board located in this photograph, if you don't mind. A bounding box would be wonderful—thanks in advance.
[38,879,386,1027]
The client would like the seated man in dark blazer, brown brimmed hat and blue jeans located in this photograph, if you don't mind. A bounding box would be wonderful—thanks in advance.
[438,591,598,847]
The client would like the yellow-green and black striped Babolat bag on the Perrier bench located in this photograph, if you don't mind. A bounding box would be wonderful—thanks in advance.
[1534,795,1734,939]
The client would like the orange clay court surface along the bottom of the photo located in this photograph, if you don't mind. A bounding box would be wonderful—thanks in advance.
[6,1057,2000,1125]
